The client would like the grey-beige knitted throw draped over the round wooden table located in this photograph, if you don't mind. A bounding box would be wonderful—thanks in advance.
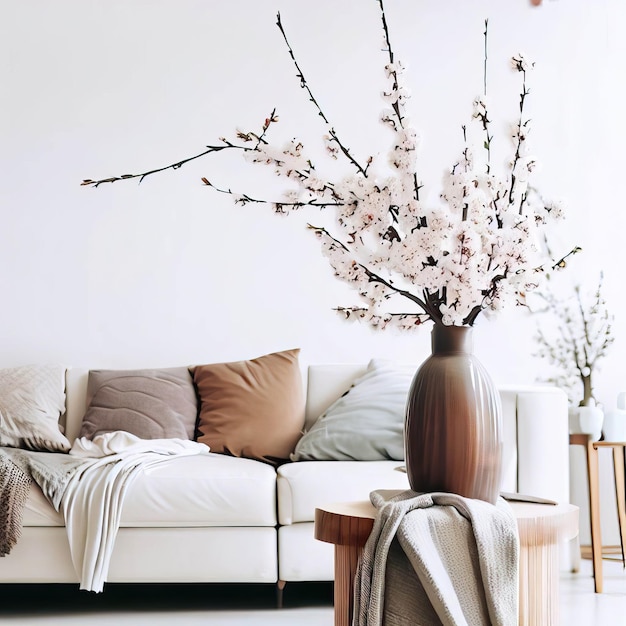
[353,490,519,626]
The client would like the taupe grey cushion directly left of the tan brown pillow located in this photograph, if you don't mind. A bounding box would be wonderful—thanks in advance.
[79,367,198,439]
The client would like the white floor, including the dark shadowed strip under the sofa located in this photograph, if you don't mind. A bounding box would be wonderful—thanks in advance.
[0,560,626,626]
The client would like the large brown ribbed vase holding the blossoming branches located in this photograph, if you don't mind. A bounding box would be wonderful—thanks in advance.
[404,325,502,504]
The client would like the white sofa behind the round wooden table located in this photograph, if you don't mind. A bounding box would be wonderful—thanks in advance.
[0,365,569,589]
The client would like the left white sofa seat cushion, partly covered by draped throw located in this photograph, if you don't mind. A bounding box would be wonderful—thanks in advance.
[24,453,276,527]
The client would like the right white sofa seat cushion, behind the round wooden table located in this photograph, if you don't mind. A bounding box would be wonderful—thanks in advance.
[277,461,409,525]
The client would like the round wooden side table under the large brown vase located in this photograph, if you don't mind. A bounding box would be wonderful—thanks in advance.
[315,500,578,626]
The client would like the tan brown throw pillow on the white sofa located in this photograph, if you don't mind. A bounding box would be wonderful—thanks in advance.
[192,349,304,465]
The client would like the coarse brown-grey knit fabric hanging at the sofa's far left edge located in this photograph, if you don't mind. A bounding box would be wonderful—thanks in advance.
[0,450,31,557]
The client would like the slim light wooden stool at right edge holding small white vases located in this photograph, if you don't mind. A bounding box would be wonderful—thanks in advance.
[569,433,626,593]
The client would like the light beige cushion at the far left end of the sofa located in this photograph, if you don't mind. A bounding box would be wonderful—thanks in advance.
[0,364,70,452]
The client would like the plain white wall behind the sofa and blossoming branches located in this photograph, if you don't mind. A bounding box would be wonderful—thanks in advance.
[0,0,626,532]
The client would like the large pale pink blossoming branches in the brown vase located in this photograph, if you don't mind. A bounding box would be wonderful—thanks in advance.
[82,0,574,329]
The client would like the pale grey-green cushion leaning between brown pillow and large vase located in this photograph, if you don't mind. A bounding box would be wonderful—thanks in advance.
[291,359,415,461]
